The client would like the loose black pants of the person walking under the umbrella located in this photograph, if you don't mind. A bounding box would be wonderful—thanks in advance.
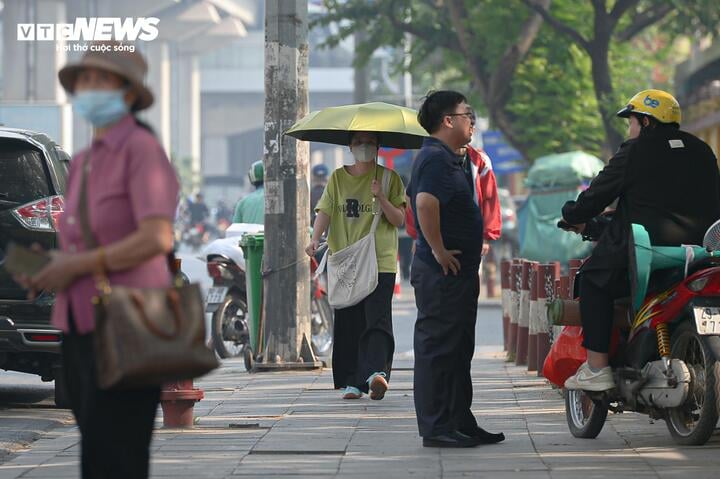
[332,273,395,392]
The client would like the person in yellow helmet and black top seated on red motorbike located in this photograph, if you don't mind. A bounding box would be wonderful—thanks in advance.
[559,90,720,391]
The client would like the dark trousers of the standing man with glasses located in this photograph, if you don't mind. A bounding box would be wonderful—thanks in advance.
[411,256,480,437]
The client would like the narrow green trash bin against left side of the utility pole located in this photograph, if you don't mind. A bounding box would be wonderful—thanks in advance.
[240,233,265,361]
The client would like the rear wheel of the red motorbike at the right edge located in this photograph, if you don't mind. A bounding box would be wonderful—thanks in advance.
[665,323,720,446]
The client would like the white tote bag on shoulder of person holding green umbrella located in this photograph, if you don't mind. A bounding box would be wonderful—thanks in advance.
[315,170,390,309]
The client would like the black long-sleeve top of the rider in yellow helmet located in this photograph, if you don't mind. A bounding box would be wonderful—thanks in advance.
[562,126,720,270]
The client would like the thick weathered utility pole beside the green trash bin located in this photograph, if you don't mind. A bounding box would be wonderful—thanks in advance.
[256,0,322,370]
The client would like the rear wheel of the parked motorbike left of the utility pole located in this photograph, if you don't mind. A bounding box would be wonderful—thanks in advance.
[212,294,250,359]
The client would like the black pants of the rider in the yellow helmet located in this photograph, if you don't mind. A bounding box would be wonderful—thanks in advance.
[578,269,630,353]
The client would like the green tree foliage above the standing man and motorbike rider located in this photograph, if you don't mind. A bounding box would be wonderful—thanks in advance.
[316,0,720,163]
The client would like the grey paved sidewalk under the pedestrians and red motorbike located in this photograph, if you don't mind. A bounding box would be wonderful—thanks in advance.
[0,352,720,479]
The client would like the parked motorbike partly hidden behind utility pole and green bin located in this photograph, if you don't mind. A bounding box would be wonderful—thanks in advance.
[202,223,333,358]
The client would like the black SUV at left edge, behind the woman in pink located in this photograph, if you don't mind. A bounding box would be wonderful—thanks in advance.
[0,127,70,407]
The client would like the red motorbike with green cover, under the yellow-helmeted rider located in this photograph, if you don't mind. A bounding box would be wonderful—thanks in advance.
[549,222,720,445]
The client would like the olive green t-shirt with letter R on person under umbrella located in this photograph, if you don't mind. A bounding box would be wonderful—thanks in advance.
[315,165,405,273]
